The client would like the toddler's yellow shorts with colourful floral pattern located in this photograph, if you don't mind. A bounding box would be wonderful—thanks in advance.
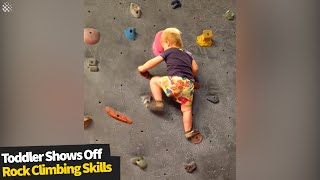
[160,76,194,105]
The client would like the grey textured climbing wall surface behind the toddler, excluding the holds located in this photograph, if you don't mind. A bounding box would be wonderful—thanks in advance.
[83,0,236,180]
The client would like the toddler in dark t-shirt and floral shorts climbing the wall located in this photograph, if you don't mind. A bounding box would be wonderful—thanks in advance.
[138,28,199,139]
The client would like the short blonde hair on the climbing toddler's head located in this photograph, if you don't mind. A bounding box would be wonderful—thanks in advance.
[161,28,183,48]
